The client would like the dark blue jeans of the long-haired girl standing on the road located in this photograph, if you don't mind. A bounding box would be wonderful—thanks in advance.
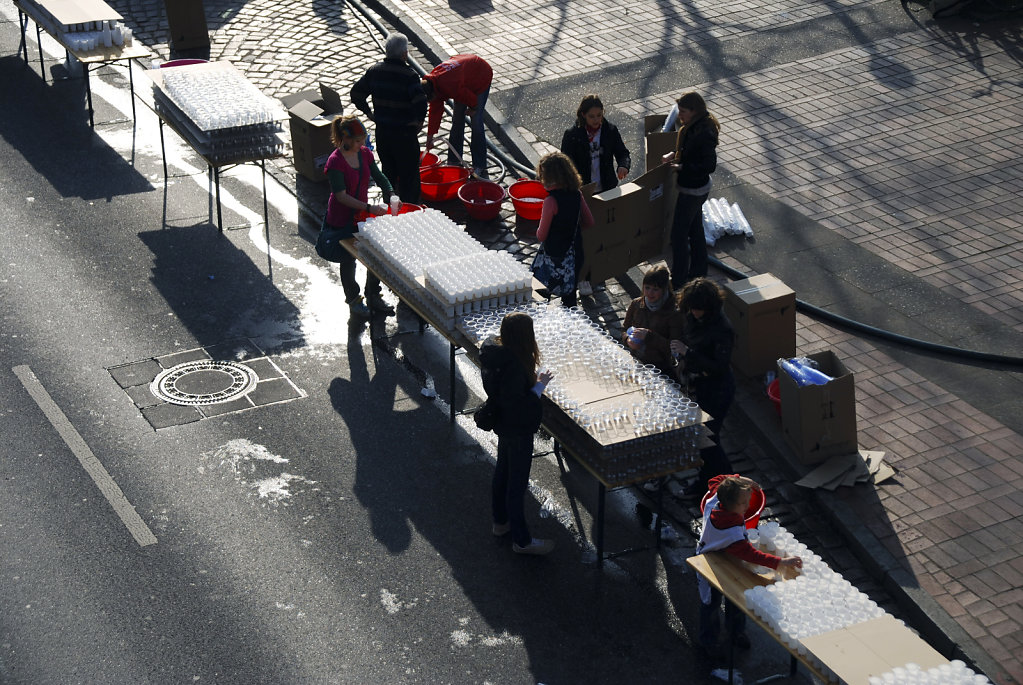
[491,432,533,547]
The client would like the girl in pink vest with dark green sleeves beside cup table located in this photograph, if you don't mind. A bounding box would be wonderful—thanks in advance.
[320,116,394,318]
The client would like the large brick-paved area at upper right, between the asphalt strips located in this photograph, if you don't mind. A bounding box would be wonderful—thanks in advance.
[617,33,1023,337]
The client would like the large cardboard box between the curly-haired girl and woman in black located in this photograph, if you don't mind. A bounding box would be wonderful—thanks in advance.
[580,166,677,283]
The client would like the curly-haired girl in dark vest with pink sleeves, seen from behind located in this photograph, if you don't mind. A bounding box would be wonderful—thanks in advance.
[536,152,593,307]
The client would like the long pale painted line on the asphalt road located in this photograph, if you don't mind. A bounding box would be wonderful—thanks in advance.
[11,366,157,547]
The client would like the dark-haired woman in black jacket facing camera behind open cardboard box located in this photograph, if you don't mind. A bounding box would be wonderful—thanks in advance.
[562,95,632,192]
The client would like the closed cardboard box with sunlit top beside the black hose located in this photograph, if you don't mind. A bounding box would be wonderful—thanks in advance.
[724,274,796,376]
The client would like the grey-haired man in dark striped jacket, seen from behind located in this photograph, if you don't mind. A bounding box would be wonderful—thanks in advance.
[350,34,427,203]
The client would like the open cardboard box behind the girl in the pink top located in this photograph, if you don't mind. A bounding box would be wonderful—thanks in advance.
[280,84,344,181]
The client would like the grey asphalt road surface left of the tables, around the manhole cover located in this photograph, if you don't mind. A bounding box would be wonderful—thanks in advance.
[0,12,822,684]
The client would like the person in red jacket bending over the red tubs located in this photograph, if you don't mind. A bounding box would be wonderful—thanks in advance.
[422,55,494,179]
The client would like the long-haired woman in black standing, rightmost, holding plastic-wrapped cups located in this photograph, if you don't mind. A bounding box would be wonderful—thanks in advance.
[664,93,721,289]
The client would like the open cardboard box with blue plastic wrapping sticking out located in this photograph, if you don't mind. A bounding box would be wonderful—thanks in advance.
[777,350,858,464]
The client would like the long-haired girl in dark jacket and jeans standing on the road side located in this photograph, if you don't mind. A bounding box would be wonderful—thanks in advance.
[480,312,554,554]
